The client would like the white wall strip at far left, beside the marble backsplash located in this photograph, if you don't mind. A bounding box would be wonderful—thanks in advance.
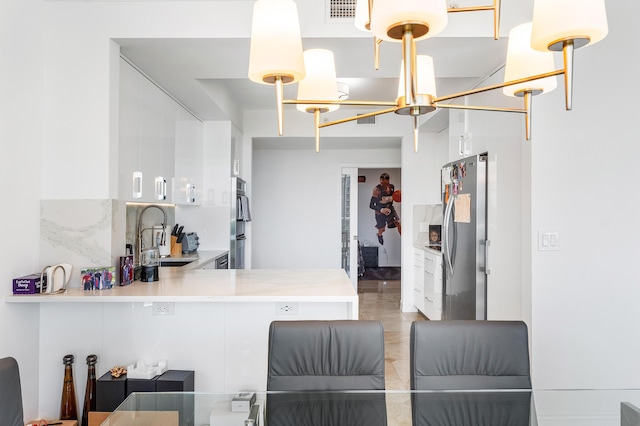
[0,0,44,418]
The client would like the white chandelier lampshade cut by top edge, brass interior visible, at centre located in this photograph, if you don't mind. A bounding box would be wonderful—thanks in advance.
[371,0,448,41]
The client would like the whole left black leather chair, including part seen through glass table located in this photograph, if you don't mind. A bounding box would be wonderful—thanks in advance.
[265,321,387,426]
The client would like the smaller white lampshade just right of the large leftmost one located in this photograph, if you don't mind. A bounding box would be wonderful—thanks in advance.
[296,49,340,112]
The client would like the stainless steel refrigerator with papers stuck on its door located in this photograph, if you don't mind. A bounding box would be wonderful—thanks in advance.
[442,153,488,320]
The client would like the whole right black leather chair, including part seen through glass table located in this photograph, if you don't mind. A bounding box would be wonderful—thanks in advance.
[410,321,531,426]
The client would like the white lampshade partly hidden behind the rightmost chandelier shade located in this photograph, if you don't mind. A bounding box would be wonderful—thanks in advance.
[502,22,558,96]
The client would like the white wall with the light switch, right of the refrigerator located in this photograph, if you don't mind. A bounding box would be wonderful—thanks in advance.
[531,1,640,388]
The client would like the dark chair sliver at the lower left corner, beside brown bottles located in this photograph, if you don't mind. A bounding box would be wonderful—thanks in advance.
[0,357,24,426]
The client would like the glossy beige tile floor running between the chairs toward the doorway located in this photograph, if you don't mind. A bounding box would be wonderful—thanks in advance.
[358,280,424,390]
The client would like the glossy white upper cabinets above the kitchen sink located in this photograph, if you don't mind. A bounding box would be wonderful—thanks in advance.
[118,60,203,204]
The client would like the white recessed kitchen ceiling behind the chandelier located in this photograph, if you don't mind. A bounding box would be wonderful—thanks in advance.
[115,0,533,148]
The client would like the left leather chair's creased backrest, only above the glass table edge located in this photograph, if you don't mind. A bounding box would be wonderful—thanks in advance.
[267,320,384,391]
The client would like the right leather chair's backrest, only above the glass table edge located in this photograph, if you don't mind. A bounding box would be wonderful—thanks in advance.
[410,321,531,390]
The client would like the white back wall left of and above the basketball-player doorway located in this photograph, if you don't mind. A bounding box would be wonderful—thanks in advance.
[250,148,400,268]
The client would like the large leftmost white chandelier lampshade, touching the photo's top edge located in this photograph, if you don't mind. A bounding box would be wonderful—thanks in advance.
[249,0,304,84]
